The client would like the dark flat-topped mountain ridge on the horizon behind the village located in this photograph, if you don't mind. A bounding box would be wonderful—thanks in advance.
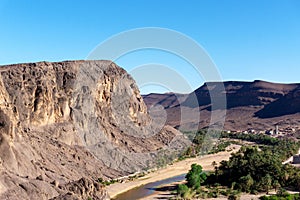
[143,80,300,130]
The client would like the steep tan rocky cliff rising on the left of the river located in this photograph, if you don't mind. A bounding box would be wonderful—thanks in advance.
[0,61,186,199]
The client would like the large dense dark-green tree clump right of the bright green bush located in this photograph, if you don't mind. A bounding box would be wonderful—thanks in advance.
[207,147,300,193]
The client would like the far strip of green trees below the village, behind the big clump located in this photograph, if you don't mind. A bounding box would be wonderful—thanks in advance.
[179,129,300,160]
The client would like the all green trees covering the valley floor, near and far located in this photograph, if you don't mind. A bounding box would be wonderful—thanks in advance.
[177,130,300,199]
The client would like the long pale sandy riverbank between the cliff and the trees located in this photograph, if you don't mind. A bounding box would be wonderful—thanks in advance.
[106,145,240,198]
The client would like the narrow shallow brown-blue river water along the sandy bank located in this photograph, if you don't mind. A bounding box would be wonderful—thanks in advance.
[114,174,185,200]
